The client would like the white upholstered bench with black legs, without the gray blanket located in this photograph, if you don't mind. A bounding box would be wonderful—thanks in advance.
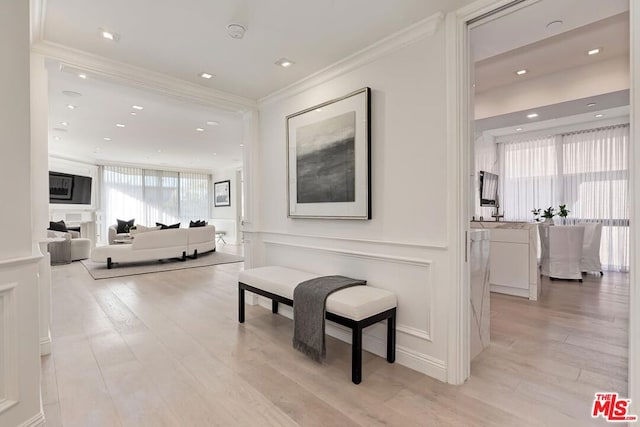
[238,266,397,384]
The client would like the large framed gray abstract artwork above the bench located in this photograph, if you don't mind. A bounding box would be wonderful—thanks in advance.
[287,87,371,219]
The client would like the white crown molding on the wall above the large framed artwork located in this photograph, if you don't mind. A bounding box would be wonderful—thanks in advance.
[258,12,444,107]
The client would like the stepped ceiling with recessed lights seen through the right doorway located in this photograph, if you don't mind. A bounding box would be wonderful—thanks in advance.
[470,0,629,134]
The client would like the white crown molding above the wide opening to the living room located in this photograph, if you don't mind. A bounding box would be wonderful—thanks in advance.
[31,40,257,112]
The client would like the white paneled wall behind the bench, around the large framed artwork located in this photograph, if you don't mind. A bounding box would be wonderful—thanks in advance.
[250,17,450,380]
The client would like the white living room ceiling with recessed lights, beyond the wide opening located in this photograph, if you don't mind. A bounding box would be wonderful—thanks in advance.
[48,62,242,170]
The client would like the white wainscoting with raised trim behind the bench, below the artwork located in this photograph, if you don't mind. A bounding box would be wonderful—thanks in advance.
[245,231,448,381]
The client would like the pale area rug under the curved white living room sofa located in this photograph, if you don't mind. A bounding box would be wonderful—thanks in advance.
[81,252,244,280]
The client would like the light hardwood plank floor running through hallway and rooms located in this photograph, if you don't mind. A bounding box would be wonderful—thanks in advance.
[42,249,628,427]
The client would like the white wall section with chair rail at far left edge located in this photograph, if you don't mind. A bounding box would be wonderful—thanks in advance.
[0,0,43,426]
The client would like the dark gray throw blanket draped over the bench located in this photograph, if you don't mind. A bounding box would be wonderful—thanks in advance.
[293,276,367,362]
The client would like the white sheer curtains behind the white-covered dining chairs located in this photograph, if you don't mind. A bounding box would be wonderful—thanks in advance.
[499,125,629,271]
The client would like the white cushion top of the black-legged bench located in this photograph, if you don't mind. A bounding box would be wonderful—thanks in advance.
[238,266,397,320]
